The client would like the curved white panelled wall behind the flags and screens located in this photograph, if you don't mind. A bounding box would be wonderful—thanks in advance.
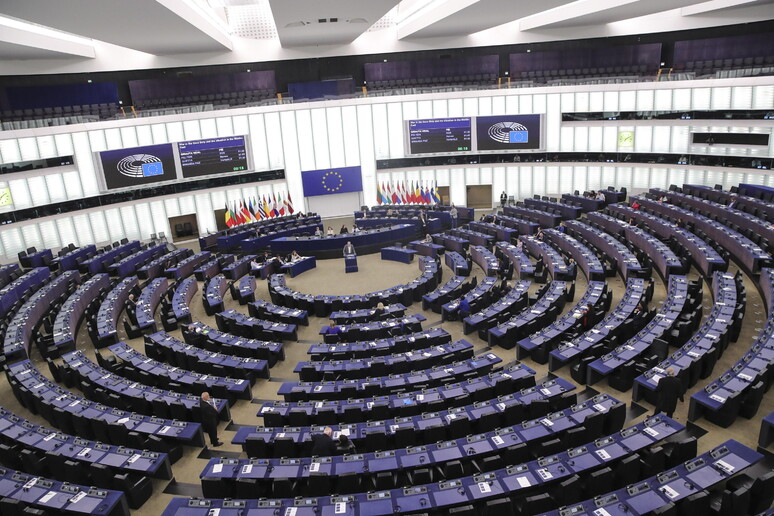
[0,77,774,258]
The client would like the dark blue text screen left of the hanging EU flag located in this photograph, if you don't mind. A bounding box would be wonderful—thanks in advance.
[177,136,250,177]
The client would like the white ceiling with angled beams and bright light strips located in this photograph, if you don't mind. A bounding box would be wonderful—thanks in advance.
[0,0,774,75]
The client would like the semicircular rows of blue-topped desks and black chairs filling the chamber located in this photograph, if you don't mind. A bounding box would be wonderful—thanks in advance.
[0,185,774,516]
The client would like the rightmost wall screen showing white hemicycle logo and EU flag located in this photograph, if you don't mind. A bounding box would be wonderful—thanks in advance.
[476,115,541,151]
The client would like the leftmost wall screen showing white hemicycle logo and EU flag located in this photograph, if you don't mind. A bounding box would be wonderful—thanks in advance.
[99,143,177,190]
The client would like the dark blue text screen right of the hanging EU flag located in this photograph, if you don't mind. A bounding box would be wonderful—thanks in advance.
[407,117,473,154]
